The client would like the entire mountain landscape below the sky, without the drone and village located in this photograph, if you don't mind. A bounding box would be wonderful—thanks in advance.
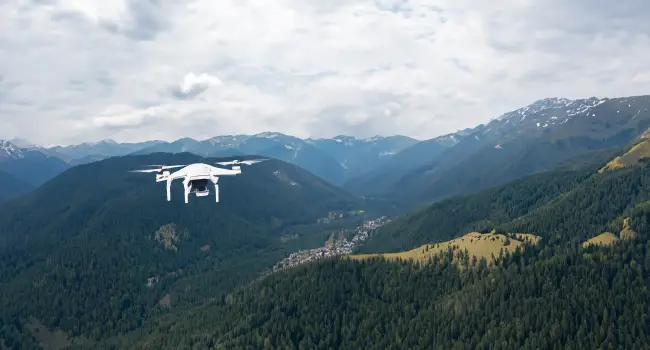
[0,96,650,349]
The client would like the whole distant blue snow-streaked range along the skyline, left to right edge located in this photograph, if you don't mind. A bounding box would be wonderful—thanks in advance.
[6,96,650,208]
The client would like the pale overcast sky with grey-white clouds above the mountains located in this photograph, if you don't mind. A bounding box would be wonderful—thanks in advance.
[0,0,650,145]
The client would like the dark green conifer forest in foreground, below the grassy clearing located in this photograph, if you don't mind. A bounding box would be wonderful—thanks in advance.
[116,217,650,349]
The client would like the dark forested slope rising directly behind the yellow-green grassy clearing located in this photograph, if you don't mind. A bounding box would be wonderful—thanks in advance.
[361,165,599,253]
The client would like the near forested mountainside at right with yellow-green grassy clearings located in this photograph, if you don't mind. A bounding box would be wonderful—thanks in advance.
[116,141,650,349]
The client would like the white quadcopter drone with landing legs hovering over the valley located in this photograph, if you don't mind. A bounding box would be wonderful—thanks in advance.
[131,159,268,203]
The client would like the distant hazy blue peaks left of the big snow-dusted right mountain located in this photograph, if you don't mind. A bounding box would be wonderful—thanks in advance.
[0,132,418,185]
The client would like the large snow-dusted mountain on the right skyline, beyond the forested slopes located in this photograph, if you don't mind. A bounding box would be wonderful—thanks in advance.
[344,96,650,203]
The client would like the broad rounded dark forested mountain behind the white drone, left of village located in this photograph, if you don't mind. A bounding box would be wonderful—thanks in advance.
[0,153,363,348]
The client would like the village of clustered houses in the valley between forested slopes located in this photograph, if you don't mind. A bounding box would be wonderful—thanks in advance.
[272,216,389,272]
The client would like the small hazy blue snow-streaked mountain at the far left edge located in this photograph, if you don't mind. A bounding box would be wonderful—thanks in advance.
[0,140,70,186]
